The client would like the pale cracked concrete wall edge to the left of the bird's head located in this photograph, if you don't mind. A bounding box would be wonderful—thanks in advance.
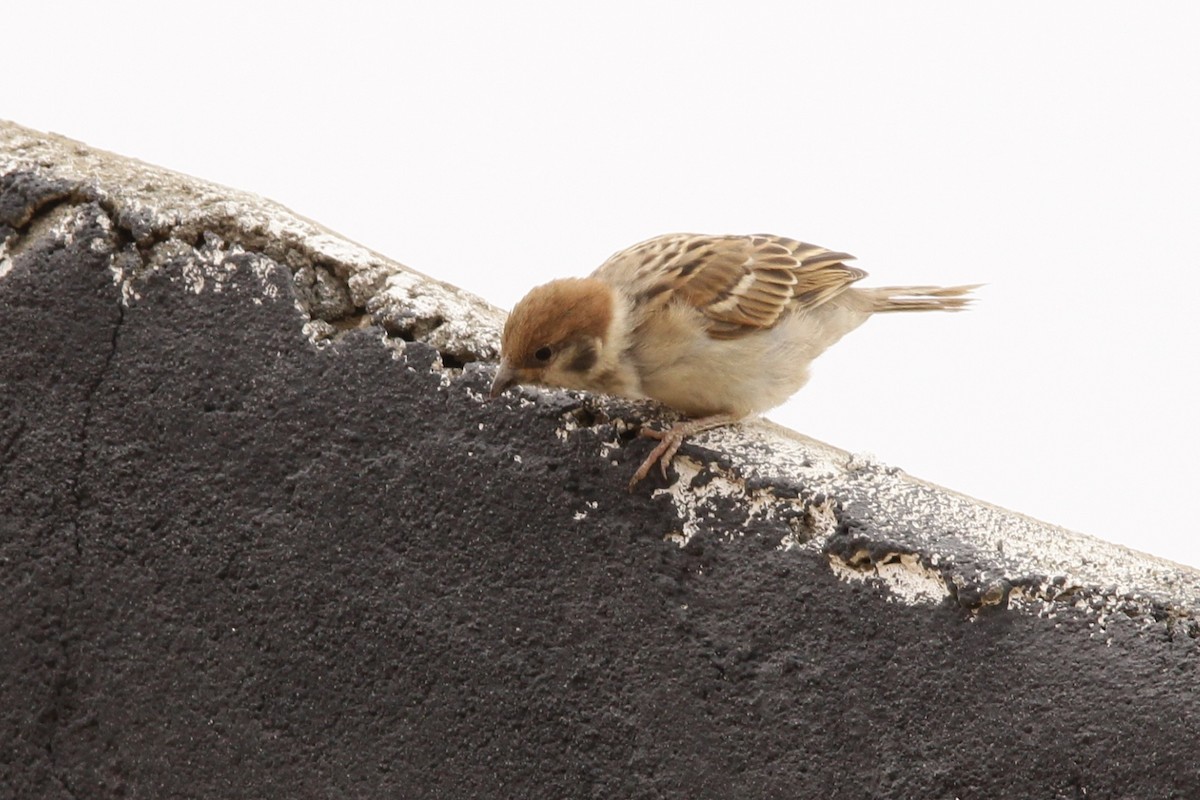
[0,120,504,367]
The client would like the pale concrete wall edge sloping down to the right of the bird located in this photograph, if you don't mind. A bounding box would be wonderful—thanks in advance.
[697,420,1200,634]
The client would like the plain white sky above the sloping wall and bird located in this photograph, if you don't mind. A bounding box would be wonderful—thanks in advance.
[9,0,1200,566]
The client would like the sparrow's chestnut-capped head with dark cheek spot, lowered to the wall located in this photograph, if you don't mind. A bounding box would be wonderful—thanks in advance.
[492,278,616,397]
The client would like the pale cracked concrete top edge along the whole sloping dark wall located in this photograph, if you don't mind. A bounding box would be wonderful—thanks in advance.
[0,121,1200,634]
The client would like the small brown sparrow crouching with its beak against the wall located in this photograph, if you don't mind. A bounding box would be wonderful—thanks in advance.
[492,234,976,488]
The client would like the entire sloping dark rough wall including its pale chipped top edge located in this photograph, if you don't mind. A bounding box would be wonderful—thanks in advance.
[0,125,1200,798]
